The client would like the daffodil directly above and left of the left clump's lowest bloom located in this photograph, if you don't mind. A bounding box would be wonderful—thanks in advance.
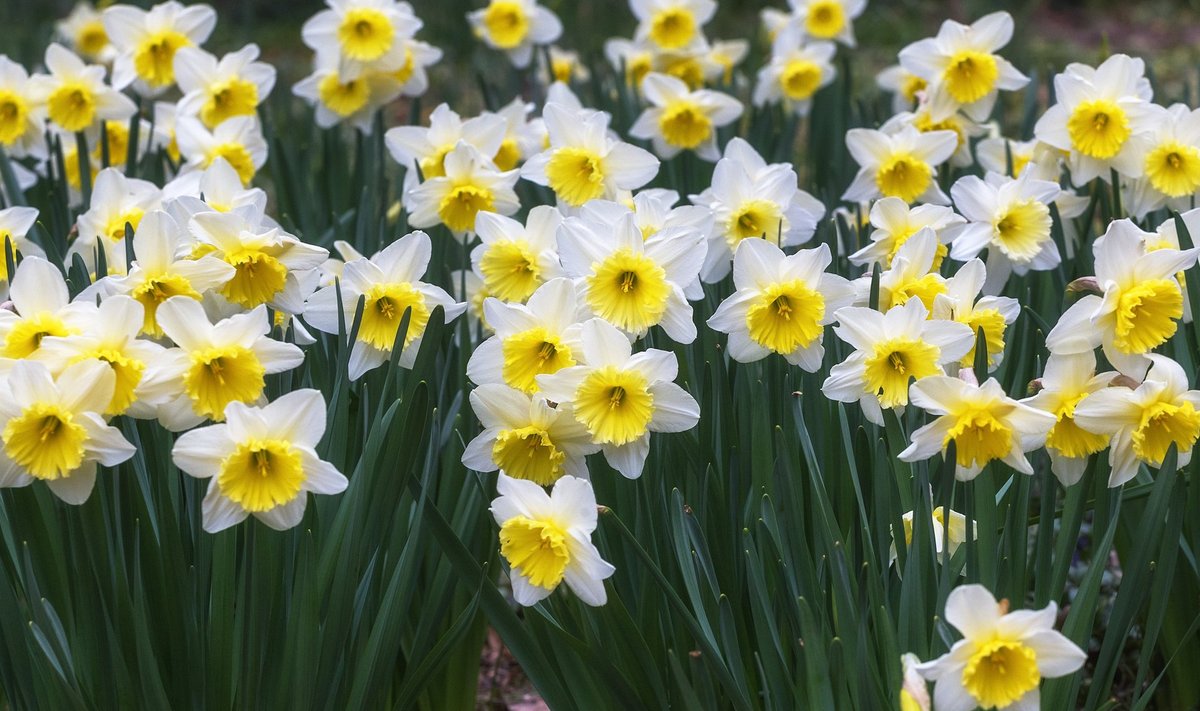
[150,295,304,432]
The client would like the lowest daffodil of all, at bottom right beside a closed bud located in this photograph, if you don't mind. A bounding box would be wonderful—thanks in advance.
[917,585,1087,711]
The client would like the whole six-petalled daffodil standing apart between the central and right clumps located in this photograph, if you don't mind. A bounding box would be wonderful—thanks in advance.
[708,239,854,372]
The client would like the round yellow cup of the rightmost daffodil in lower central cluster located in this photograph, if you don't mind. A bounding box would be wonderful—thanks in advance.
[575,365,654,446]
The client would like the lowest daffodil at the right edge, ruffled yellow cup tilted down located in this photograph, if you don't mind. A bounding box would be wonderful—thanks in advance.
[1075,354,1200,486]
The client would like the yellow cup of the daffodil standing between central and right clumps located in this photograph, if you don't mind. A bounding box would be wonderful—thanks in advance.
[746,280,824,356]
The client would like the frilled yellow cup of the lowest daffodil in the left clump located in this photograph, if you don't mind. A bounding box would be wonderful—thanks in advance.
[217,440,305,512]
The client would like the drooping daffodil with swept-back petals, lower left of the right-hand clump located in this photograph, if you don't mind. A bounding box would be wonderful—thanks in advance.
[900,375,1055,482]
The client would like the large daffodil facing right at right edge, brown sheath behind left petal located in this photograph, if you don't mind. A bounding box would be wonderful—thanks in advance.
[1046,220,1196,380]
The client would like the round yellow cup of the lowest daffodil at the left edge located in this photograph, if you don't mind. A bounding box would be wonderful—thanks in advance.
[2,404,88,480]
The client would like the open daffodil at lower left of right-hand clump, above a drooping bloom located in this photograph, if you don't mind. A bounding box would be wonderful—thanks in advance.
[821,299,974,424]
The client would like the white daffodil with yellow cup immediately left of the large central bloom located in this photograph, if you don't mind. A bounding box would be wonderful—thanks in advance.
[470,205,563,301]
